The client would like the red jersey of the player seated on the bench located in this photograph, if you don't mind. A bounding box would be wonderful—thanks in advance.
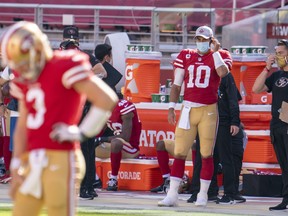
[107,100,142,150]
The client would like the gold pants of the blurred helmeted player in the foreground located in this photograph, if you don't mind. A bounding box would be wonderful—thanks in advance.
[13,150,85,216]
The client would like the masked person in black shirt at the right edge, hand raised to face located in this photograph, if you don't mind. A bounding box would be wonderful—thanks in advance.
[252,40,288,211]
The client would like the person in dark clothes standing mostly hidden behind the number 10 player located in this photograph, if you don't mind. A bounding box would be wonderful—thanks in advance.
[187,73,246,204]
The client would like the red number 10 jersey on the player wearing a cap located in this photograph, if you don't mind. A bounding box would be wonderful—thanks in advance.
[174,49,232,105]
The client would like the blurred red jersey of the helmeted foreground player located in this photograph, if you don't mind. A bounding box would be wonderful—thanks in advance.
[11,50,93,150]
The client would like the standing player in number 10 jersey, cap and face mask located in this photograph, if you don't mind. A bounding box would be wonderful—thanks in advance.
[158,26,232,206]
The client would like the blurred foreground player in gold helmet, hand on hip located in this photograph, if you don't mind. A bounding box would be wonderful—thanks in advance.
[1,21,118,216]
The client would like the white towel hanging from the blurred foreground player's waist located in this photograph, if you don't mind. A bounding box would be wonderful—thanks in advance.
[20,149,48,199]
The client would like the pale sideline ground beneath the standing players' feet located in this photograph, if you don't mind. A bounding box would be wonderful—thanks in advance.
[0,184,288,216]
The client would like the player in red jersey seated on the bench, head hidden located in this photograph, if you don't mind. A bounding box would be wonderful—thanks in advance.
[95,99,142,191]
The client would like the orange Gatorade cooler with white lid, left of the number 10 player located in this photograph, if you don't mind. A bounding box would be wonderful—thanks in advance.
[123,51,162,103]
